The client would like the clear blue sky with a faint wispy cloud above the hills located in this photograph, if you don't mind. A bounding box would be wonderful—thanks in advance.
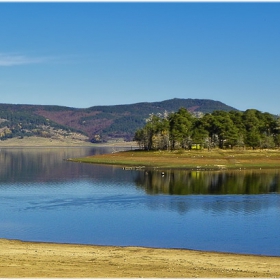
[0,2,280,114]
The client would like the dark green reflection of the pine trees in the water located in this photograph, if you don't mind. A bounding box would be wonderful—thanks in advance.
[135,170,280,195]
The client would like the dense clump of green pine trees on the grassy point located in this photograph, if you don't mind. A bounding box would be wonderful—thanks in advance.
[134,108,280,150]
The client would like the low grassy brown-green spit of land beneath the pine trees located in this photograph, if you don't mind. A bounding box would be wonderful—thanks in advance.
[69,149,280,170]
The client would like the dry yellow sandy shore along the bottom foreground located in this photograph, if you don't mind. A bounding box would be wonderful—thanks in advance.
[0,239,280,278]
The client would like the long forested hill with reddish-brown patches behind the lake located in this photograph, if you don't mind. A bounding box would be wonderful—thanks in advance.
[0,98,236,142]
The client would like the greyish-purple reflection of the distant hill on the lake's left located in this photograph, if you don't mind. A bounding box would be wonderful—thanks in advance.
[0,147,129,183]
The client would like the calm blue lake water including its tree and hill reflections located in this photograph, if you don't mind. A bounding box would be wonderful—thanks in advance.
[0,148,280,256]
